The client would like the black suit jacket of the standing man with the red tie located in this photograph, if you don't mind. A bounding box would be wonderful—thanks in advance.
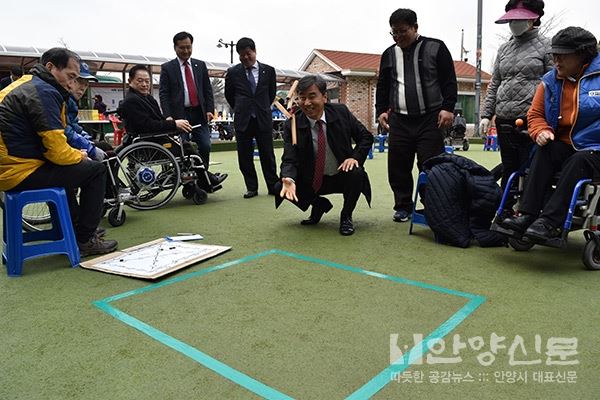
[158,58,215,123]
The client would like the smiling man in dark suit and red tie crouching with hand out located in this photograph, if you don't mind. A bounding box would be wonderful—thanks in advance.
[276,75,373,236]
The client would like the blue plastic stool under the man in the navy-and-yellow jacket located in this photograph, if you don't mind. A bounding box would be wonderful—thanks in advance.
[2,188,80,276]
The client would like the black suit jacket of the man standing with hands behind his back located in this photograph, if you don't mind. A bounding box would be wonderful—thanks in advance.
[225,62,276,132]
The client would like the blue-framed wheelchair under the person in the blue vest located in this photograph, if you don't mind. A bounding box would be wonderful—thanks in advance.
[490,171,600,270]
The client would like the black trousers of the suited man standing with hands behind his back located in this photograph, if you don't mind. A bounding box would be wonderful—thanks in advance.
[235,118,279,192]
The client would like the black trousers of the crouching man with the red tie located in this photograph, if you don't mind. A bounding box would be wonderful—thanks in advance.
[278,167,366,217]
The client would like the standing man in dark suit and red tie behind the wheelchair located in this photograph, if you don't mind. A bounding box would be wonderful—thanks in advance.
[159,32,227,184]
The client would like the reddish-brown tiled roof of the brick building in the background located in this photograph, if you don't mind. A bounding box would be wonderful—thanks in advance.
[314,49,492,80]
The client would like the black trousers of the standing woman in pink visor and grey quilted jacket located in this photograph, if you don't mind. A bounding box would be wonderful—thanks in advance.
[496,118,534,189]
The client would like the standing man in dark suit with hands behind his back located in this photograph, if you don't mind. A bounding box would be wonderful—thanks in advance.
[225,37,279,199]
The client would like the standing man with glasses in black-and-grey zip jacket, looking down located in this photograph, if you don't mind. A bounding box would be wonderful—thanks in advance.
[375,8,457,222]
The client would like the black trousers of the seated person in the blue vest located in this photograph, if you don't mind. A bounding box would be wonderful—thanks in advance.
[520,140,600,227]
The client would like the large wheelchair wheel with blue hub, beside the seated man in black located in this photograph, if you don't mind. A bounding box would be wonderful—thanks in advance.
[118,142,181,210]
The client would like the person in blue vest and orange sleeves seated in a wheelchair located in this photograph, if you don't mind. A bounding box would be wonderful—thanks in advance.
[500,26,600,243]
